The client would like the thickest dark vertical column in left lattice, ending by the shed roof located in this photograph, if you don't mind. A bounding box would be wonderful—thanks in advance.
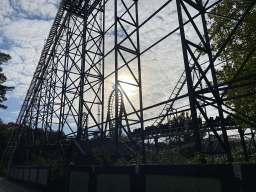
[76,0,88,140]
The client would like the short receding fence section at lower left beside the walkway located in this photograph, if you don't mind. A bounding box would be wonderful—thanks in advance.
[8,165,50,190]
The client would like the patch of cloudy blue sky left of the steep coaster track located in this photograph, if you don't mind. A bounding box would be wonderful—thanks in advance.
[0,0,60,123]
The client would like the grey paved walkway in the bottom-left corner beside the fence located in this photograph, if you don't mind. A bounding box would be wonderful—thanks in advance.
[0,177,42,192]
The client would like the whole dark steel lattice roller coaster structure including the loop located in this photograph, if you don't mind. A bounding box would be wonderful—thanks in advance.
[1,0,256,166]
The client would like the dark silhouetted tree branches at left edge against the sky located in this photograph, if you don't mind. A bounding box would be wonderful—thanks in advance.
[0,52,14,109]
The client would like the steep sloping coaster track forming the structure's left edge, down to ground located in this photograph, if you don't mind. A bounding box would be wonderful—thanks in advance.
[1,0,67,168]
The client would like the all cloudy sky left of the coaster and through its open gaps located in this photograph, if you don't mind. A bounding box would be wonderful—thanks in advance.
[0,0,248,137]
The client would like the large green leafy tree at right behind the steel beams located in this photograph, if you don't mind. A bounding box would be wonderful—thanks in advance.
[208,0,256,127]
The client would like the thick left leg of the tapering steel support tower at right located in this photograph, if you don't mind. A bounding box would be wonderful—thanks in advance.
[176,0,202,152]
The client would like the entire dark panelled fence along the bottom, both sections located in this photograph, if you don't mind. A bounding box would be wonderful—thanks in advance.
[9,164,256,192]
